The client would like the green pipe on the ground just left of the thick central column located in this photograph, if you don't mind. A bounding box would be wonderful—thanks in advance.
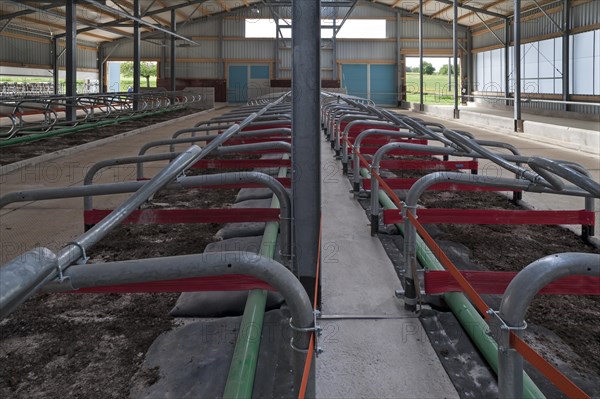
[223,156,288,399]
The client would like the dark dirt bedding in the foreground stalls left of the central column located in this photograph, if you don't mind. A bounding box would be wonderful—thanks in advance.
[0,165,244,399]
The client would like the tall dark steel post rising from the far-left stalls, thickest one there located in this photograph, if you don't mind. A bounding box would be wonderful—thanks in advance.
[65,0,77,121]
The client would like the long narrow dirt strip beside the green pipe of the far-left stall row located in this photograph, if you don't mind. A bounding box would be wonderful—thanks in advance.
[0,108,198,165]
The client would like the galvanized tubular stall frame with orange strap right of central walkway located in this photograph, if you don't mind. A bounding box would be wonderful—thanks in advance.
[323,96,600,398]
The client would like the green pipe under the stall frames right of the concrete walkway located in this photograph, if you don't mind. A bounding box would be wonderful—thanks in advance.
[360,168,545,399]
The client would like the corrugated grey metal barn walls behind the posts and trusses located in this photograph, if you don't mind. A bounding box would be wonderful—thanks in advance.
[0,0,600,112]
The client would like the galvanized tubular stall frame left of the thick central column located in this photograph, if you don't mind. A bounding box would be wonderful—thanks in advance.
[0,93,324,397]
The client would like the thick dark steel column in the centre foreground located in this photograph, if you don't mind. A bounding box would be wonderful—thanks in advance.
[292,1,321,310]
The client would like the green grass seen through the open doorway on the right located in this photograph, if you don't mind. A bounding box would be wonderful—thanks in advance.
[406,72,462,105]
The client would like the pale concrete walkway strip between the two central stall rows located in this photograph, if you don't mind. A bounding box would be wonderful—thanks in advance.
[316,136,458,398]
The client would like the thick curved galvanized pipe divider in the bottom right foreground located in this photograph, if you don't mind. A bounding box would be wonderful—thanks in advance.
[489,253,600,399]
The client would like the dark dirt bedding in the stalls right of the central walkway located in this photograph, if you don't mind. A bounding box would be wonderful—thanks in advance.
[421,192,600,375]
